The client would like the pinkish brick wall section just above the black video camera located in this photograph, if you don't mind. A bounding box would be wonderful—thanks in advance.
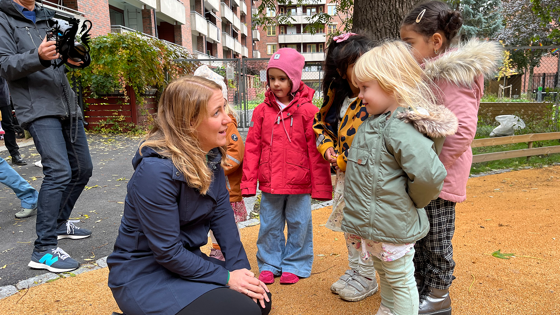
[75,0,111,37]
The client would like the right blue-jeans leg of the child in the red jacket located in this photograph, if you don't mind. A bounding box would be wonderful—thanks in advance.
[282,194,313,278]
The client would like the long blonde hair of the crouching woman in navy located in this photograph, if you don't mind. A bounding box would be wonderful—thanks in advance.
[140,77,226,194]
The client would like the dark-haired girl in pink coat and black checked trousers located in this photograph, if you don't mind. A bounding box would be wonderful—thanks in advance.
[400,1,502,315]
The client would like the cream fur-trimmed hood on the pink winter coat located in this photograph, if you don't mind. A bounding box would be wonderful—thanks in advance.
[423,39,503,87]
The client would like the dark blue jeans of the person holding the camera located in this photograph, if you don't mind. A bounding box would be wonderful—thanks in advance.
[29,117,93,251]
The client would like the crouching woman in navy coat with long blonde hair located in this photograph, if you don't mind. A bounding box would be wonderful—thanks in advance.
[107,77,270,315]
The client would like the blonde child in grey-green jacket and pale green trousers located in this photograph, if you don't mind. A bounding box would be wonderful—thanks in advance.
[342,41,457,315]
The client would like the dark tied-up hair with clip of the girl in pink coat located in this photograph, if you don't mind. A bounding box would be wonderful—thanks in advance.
[401,1,463,47]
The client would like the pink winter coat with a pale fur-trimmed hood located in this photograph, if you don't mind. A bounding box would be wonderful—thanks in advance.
[424,40,502,202]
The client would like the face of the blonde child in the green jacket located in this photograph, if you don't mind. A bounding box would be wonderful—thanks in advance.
[358,80,399,115]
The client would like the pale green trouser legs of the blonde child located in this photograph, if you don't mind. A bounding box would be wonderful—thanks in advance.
[373,249,419,315]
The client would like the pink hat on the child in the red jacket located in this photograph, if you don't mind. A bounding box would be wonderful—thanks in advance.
[266,48,305,93]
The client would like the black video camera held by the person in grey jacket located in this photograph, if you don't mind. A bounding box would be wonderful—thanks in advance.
[47,18,92,69]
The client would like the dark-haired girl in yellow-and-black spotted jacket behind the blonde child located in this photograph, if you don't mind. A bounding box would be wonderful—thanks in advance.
[313,33,377,301]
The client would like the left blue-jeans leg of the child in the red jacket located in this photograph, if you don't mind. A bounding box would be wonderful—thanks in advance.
[257,192,286,276]
